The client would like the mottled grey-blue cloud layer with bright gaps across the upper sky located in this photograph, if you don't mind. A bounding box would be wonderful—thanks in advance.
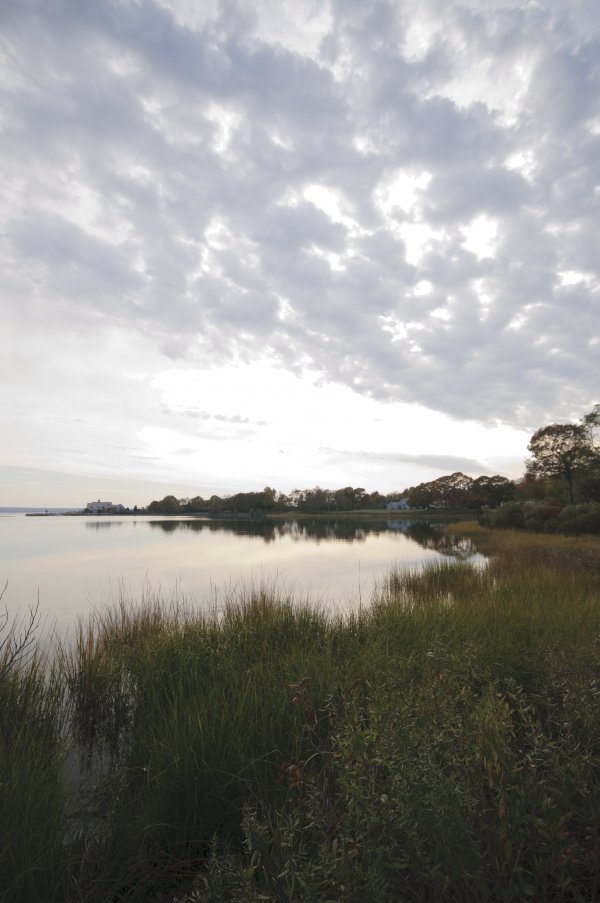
[0,0,600,484]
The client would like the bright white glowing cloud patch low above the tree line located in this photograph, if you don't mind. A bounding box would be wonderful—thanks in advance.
[141,360,525,490]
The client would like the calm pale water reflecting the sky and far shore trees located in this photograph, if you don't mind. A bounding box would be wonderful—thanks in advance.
[0,515,483,631]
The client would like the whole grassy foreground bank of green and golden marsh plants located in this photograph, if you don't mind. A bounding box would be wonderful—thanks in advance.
[0,524,600,903]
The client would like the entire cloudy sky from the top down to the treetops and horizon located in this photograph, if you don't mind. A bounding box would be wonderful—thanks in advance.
[0,0,600,506]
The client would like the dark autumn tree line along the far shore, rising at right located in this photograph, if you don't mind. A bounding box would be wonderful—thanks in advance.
[146,404,600,516]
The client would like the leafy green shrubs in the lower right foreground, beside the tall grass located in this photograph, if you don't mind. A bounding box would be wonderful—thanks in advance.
[181,676,598,903]
